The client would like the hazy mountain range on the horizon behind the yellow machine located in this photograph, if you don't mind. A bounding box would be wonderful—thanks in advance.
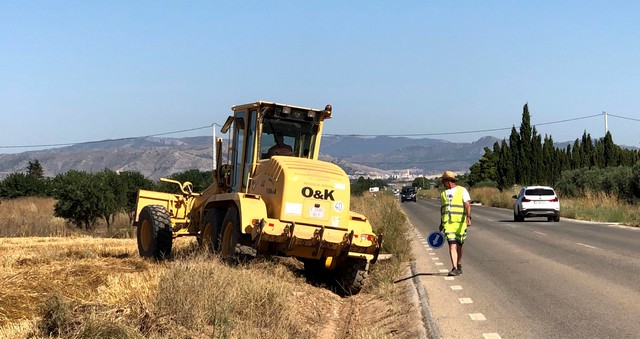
[0,136,500,180]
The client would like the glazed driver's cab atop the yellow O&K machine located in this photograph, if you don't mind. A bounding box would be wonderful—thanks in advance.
[216,101,331,192]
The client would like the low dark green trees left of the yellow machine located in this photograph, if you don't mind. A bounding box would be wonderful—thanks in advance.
[0,160,213,230]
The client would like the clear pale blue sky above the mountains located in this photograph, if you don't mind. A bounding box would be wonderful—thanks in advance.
[0,1,640,153]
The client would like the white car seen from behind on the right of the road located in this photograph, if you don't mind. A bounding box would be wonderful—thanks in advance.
[513,186,560,222]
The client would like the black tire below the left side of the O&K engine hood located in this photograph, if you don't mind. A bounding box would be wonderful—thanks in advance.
[218,207,256,262]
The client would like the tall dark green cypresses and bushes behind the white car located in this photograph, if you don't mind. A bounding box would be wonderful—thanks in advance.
[465,104,640,202]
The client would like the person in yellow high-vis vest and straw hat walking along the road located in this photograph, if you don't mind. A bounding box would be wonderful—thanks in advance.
[440,171,471,276]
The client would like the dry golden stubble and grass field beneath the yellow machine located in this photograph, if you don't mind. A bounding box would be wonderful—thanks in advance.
[0,237,420,338]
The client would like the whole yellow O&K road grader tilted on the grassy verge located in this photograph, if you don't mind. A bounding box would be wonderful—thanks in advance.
[135,101,382,294]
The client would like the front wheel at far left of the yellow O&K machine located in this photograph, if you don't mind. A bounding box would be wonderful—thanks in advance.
[137,205,173,260]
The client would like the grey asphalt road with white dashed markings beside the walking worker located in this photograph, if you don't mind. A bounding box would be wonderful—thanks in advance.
[402,200,640,338]
